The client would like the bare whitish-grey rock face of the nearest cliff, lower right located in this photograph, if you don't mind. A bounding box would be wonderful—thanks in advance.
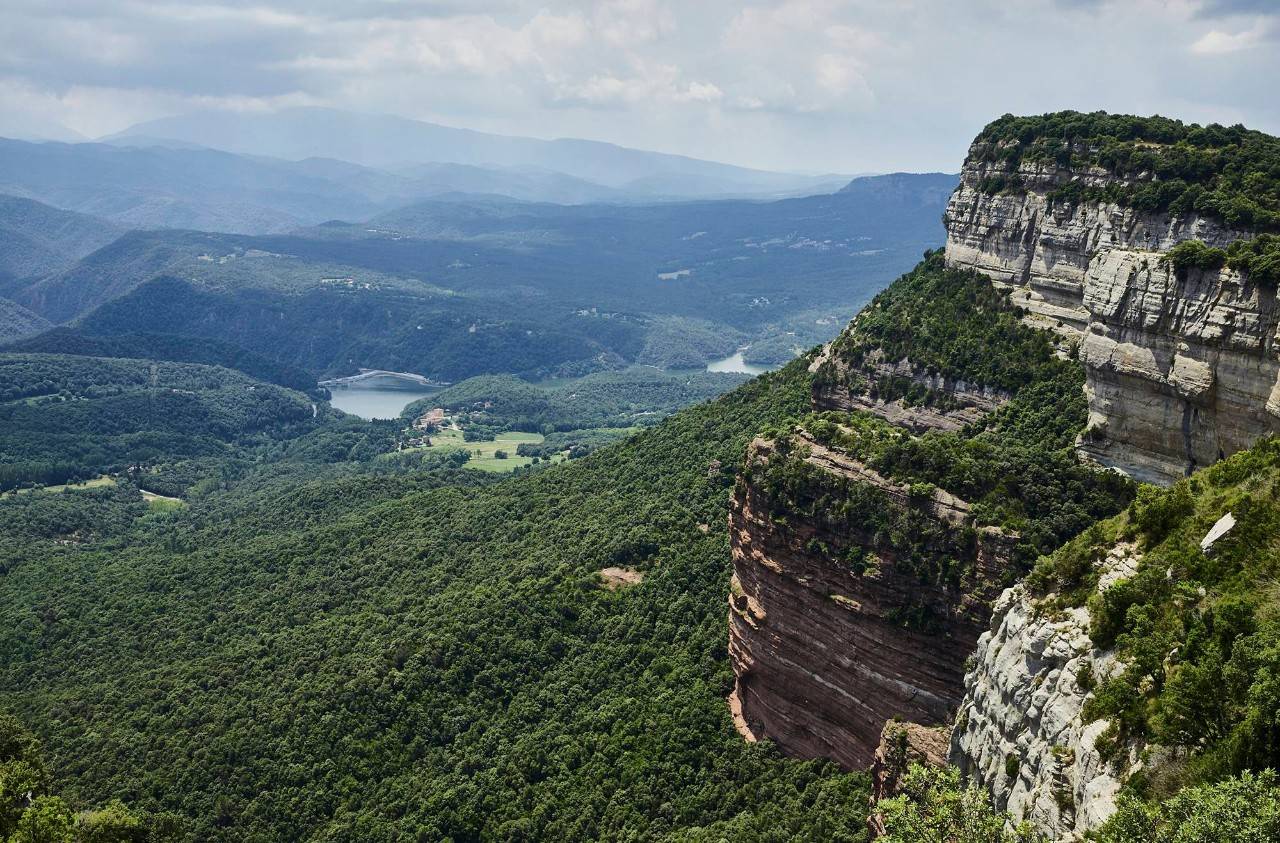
[950,544,1138,840]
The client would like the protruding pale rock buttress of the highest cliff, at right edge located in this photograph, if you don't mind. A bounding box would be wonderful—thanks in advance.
[1080,249,1280,484]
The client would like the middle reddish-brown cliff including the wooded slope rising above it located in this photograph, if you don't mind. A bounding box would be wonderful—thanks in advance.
[730,253,1129,769]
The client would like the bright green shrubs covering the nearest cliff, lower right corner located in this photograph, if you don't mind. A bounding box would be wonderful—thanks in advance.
[881,439,1280,843]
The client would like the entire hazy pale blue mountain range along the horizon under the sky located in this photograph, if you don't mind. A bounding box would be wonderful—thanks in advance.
[0,109,849,237]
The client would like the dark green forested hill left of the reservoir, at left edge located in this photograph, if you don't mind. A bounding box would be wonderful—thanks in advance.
[0,354,398,494]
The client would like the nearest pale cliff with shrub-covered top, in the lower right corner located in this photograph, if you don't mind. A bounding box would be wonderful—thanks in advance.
[950,437,1280,840]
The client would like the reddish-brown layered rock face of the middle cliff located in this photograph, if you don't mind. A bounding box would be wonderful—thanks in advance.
[730,436,1011,769]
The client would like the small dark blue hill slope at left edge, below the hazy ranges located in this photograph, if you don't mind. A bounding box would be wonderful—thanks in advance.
[0,194,124,287]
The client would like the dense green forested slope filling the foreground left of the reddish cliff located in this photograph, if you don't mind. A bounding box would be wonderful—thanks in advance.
[0,363,880,840]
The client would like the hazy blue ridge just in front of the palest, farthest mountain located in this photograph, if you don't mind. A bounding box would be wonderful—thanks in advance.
[0,138,839,234]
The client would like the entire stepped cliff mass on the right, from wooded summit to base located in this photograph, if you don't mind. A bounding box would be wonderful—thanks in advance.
[730,114,1280,839]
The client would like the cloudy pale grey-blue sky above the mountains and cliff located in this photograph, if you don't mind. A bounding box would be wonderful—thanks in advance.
[0,0,1280,174]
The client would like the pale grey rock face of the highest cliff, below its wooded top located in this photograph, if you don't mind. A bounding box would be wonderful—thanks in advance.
[945,143,1280,482]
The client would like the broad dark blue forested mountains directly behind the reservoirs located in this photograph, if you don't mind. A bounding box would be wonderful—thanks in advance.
[14,174,956,380]
